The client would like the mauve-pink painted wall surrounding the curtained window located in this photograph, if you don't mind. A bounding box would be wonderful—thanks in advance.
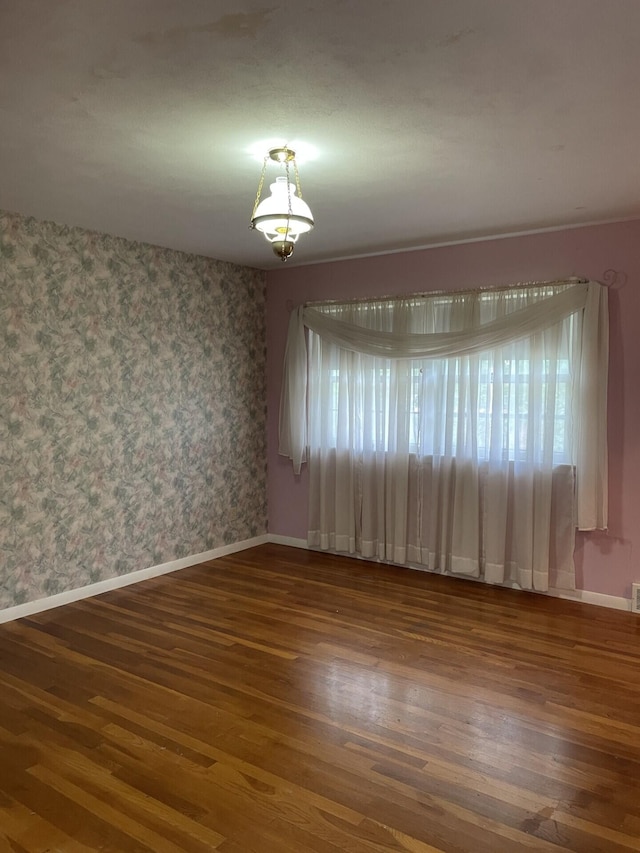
[267,221,640,598]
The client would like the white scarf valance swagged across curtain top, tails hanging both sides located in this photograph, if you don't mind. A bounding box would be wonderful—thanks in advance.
[279,280,608,529]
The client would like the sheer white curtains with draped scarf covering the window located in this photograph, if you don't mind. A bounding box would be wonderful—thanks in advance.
[281,282,608,590]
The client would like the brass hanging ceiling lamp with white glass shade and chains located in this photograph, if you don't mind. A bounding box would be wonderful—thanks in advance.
[250,147,313,261]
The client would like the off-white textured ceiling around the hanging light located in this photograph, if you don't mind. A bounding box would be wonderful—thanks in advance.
[0,0,640,268]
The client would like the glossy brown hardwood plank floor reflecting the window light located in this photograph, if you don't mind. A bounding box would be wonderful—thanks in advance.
[0,545,640,853]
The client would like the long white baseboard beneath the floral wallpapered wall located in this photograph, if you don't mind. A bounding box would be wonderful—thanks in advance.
[0,534,271,624]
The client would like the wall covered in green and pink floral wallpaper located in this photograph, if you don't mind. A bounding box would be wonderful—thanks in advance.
[0,213,266,608]
